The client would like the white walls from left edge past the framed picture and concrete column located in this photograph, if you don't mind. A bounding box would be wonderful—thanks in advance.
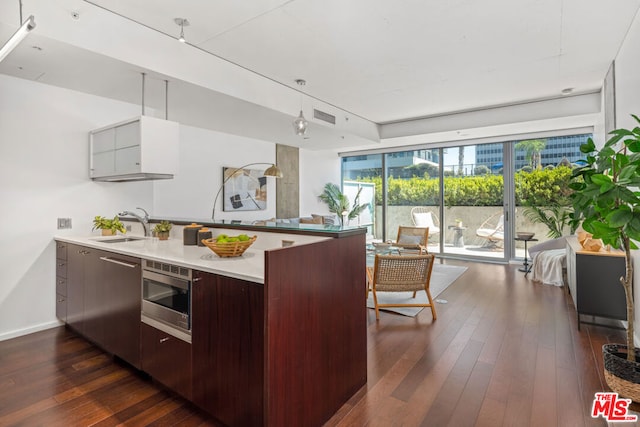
[0,74,340,340]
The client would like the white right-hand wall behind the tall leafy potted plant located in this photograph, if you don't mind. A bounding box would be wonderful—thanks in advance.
[615,8,640,346]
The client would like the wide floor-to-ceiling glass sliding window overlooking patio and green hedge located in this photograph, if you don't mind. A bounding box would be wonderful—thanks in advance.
[342,133,591,260]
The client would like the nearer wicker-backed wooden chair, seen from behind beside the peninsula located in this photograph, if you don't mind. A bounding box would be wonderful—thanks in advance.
[367,254,437,320]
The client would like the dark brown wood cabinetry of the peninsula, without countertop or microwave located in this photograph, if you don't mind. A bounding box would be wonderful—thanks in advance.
[60,230,367,427]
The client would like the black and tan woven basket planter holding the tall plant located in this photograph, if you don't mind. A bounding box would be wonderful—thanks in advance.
[602,344,640,402]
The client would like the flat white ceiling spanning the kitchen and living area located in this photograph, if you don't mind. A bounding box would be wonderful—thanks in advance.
[0,0,640,150]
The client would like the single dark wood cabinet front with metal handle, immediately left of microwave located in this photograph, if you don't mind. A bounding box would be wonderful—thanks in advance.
[99,252,142,368]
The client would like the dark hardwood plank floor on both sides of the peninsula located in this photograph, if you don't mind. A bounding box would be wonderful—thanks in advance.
[0,261,624,427]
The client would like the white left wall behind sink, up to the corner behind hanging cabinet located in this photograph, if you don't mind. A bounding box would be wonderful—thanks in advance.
[0,75,152,339]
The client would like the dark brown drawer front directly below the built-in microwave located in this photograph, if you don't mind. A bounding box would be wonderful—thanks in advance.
[140,323,192,399]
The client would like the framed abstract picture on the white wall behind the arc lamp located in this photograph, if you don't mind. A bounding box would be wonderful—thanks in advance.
[222,167,267,211]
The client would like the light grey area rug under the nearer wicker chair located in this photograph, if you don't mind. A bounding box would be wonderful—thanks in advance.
[367,264,467,317]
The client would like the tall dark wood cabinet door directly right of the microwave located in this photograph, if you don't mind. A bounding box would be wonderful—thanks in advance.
[192,271,264,426]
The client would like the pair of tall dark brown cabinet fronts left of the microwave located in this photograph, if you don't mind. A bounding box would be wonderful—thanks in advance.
[56,242,142,368]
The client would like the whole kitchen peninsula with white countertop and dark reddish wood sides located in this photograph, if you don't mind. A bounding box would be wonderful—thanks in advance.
[56,224,367,426]
